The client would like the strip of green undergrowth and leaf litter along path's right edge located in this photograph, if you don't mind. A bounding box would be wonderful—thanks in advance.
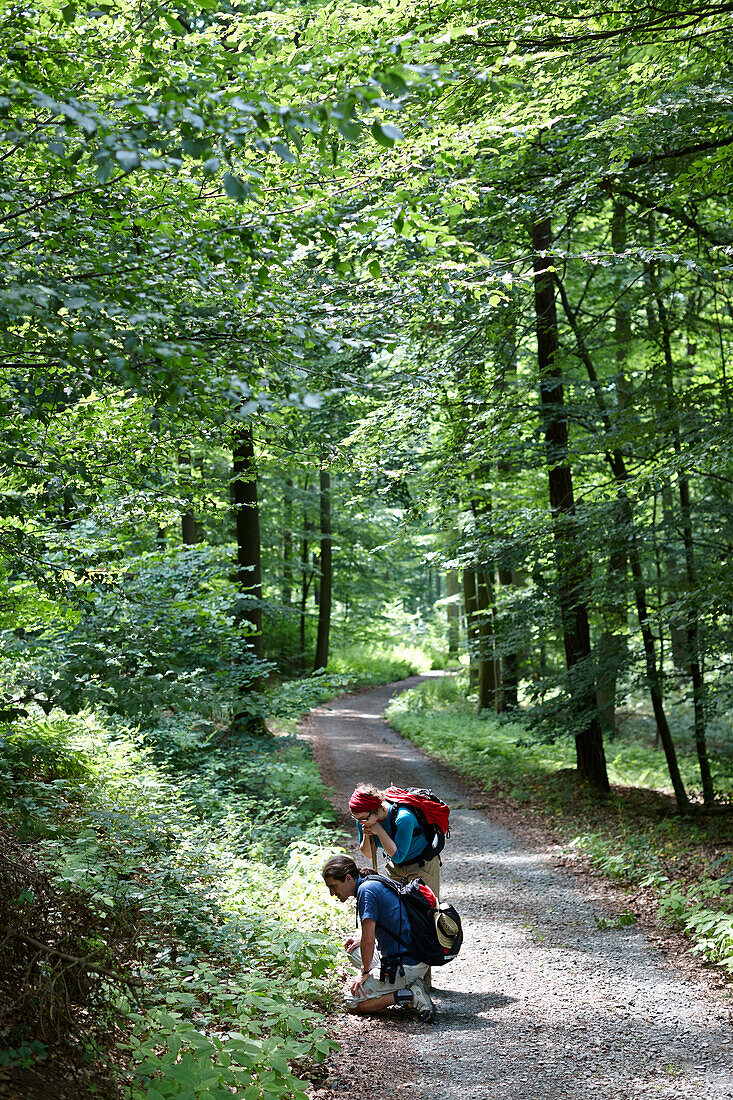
[387,678,733,974]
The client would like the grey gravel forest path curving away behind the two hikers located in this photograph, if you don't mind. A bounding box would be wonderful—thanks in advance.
[303,677,733,1100]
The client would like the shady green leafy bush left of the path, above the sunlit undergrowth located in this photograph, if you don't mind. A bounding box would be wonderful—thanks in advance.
[4,547,267,725]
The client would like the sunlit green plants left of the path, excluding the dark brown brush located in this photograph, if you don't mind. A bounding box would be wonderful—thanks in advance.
[0,712,342,1100]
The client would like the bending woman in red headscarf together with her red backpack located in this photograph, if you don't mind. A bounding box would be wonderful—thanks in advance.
[349,783,450,898]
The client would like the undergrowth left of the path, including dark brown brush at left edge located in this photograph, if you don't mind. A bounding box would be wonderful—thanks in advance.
[0,712,342,1100]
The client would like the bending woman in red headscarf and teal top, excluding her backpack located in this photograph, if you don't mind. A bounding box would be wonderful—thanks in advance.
[349,783,440,898]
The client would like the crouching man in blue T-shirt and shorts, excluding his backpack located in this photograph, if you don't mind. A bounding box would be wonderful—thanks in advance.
[321,856,435,1022]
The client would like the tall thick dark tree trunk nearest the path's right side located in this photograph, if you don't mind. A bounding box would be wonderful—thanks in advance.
[532,218,610,791]
